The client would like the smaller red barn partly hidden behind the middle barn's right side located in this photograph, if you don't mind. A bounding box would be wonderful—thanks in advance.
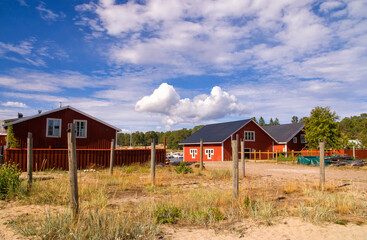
[263,122,306,152]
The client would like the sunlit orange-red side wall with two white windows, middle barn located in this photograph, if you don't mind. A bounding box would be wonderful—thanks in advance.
[184,144,222,162]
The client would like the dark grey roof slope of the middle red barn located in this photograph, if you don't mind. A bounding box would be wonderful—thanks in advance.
[180,119,252,144]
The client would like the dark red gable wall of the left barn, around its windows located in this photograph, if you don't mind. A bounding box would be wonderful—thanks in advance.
[13,108,116,149]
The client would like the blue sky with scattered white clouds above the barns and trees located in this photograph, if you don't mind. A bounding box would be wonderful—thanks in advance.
[0,0,367,131]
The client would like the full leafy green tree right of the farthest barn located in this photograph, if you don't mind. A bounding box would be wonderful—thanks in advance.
[305,107,343,149]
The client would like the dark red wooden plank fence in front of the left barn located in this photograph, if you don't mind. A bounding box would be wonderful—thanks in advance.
[4,148,166,172]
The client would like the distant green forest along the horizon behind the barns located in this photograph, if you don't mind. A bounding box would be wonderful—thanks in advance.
[117,113,367,149]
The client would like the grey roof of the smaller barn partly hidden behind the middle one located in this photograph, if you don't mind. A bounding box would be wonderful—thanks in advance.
[262,122,305,143]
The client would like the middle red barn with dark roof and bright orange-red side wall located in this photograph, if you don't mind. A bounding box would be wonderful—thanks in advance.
[180,119,277,161]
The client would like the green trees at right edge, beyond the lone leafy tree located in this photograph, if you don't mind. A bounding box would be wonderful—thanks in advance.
[340,113,367,148]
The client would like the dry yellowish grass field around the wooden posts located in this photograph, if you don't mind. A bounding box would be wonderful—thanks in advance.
[5,166,367,239]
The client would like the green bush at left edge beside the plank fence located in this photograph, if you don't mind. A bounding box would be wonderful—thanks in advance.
[0,163,21,199]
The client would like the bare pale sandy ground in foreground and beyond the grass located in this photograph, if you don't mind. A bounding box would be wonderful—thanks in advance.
[0,162,367,240]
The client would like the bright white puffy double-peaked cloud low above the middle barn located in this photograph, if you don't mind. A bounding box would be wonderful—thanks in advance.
[135,83,247,125]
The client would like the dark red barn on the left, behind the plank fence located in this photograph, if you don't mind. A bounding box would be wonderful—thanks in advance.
[5,106,121,149]
